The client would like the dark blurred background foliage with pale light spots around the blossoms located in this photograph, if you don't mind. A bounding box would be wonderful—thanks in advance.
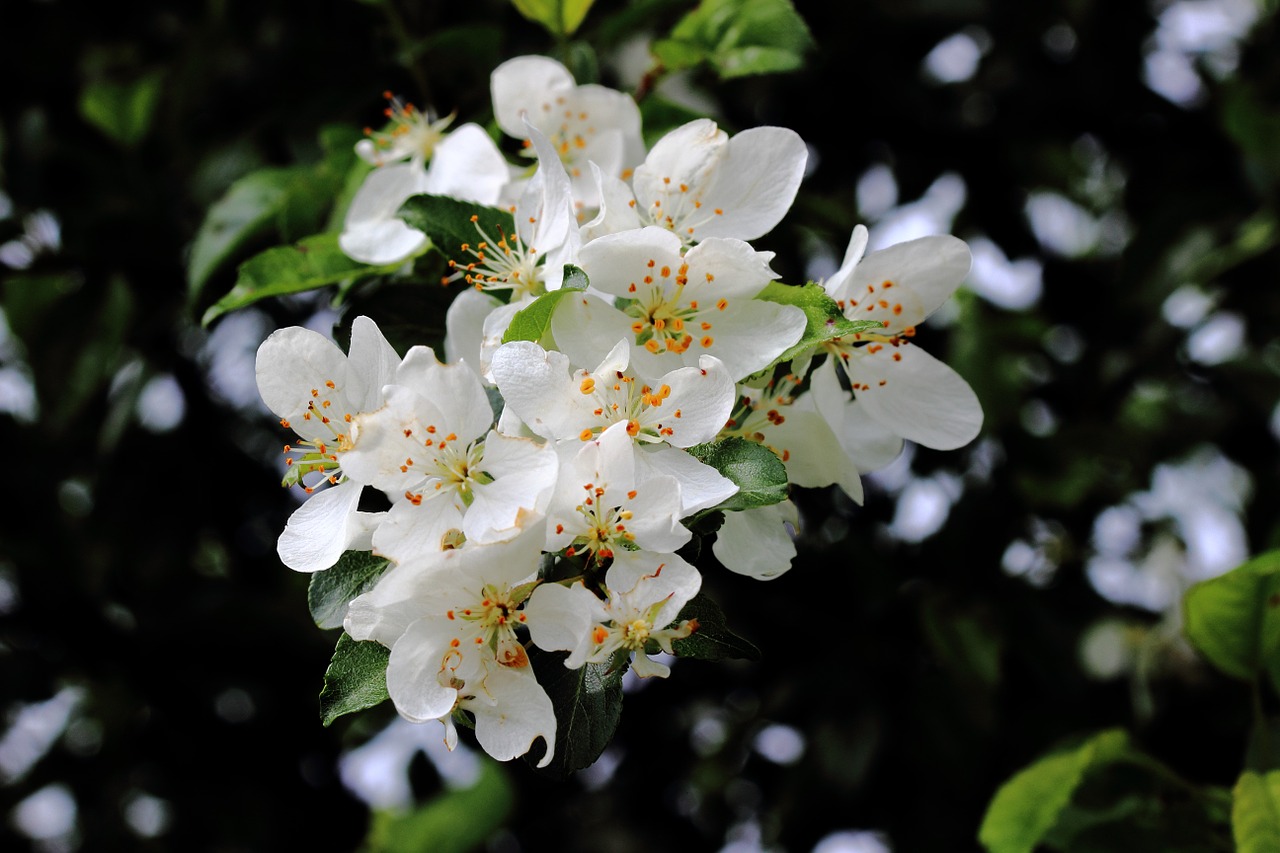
[0,0,1280,853]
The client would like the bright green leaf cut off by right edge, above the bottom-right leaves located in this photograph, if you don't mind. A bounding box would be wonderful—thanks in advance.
[1183,551,1280,683]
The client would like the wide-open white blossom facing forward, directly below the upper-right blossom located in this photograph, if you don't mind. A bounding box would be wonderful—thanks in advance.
[552,227,805,380]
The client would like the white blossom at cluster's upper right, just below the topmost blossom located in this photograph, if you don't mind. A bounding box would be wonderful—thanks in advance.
[582,119,809,243]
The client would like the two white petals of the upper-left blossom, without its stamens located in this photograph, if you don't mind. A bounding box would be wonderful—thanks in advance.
[338,124,511,265]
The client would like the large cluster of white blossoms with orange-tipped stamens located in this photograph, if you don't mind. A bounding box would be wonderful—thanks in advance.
[257,56,982,765]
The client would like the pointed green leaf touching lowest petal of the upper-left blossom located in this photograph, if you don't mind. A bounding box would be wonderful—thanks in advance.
[201,234,401,325]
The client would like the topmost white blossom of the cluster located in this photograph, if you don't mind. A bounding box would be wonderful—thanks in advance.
[490,56,644,207]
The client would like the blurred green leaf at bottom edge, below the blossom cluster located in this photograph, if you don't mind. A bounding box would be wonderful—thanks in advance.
[362,761,516,853]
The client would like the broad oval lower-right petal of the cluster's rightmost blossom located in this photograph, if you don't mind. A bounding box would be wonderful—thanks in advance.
[845,343,982,450]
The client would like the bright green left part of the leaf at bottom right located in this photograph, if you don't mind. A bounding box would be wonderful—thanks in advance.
[978,729,1133,853]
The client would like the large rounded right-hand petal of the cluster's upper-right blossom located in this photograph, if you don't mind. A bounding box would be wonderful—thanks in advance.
[695,127,809,240]
